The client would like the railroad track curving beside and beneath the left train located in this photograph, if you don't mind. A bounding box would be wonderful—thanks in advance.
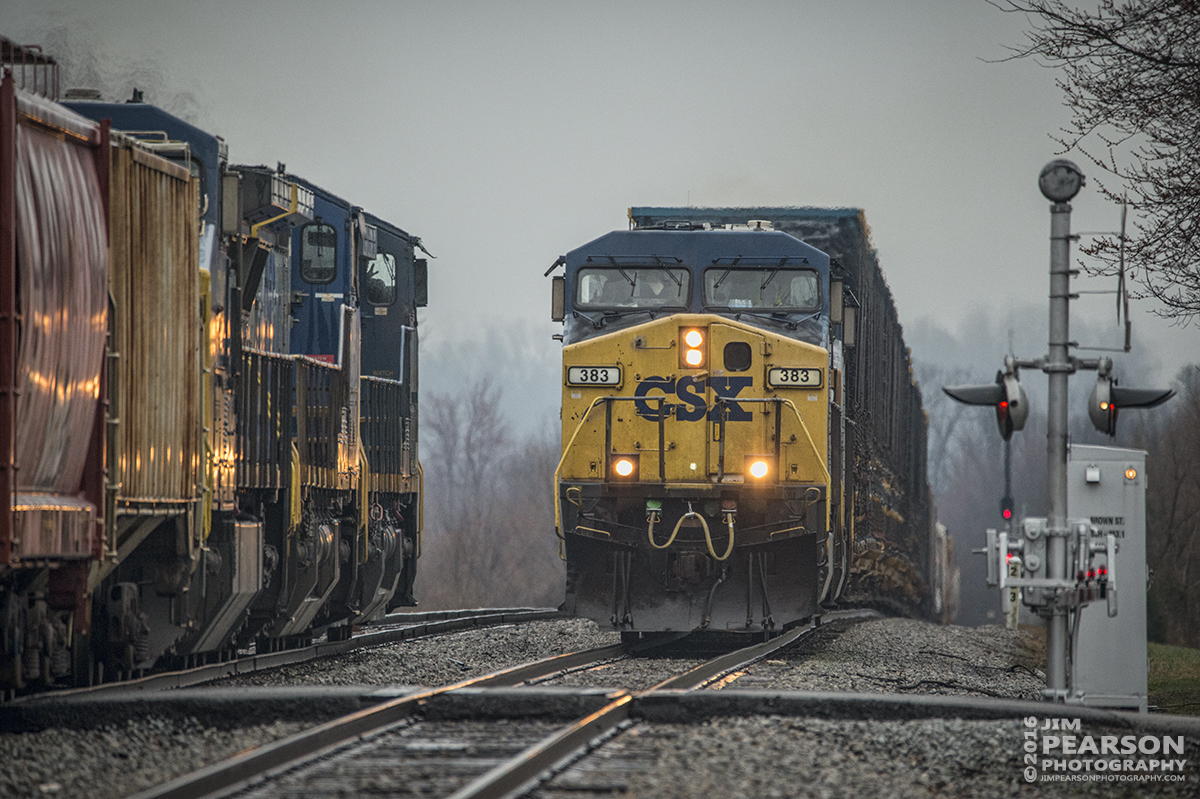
[6,607,562,705]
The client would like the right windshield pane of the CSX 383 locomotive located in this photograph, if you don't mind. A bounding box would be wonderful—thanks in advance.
[704,266,821,312]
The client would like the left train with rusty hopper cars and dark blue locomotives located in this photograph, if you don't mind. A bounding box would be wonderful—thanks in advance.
[0,41,427,692]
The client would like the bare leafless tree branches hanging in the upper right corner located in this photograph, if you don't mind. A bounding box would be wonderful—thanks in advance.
[989,0,1200,320]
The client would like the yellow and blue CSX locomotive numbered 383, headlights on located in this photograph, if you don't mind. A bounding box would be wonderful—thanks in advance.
[554,214,844,632]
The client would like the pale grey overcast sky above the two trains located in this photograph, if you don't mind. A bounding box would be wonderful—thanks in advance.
[11,0,1200,398]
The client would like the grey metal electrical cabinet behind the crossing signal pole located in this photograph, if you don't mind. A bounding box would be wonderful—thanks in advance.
[1067,445,1147,713]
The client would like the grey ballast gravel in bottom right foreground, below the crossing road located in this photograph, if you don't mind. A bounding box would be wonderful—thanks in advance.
[544,716,1200,799]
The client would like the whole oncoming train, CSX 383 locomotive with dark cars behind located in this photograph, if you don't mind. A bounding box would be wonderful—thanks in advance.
[547,208,944,637]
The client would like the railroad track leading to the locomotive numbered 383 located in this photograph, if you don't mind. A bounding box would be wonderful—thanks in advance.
[121,614,854,799]
